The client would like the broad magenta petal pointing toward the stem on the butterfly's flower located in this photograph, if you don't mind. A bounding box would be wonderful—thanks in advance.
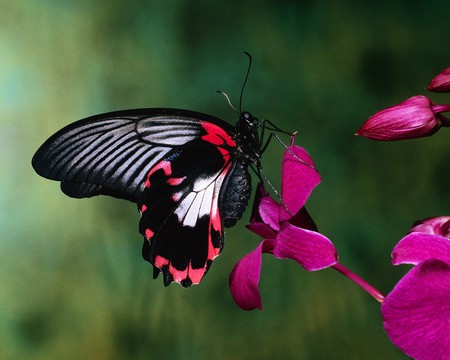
[273,223,338,271]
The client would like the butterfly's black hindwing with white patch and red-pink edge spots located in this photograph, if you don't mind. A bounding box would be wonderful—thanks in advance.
[138,139,233,286]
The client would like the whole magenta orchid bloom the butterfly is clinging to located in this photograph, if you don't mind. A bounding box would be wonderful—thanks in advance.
[230,146,337,310]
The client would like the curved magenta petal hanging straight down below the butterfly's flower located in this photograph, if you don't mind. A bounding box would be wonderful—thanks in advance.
[230,240,275,310]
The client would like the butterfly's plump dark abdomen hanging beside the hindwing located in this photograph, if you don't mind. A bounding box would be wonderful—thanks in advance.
[219,161,251,227]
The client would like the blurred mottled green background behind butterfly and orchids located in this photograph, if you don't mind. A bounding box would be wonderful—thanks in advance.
[0,0,450,360]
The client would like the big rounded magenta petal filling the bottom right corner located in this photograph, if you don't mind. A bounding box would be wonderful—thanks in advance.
[381,260,450,360]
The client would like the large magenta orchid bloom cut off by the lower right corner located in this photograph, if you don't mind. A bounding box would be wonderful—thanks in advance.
[381,216,450,360]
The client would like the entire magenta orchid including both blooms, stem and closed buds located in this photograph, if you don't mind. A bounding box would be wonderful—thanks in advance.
[230,68,450,360]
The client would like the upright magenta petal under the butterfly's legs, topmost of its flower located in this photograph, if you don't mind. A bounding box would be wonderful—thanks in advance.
[279,146,321,221]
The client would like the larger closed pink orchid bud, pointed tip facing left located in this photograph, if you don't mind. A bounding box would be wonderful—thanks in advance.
[356,95,450,141]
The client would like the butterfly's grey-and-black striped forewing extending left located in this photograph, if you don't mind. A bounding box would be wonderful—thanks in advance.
[32,109,232,202]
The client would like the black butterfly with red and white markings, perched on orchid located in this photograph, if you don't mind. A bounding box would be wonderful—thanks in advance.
[32,109,265,287]
